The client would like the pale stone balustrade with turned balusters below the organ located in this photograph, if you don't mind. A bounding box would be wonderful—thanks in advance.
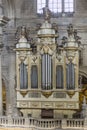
[0,117,84,129]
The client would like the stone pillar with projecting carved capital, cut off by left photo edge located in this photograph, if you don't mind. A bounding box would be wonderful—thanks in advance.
[0,0,9,115]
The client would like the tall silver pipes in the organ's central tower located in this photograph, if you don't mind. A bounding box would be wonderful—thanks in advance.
[41,54,52,90]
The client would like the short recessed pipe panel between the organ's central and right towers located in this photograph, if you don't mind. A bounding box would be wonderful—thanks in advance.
[56,65,63,89]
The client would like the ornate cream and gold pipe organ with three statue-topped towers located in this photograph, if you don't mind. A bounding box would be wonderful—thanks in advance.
[15,7,80,118]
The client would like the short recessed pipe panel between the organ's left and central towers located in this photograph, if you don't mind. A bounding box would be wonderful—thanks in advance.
[31,65,38,89]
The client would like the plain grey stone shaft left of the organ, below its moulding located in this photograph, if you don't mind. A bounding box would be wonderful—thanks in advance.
[8,50,17,116]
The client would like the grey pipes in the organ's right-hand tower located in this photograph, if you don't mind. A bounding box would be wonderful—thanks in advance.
[66,63,75,90]
